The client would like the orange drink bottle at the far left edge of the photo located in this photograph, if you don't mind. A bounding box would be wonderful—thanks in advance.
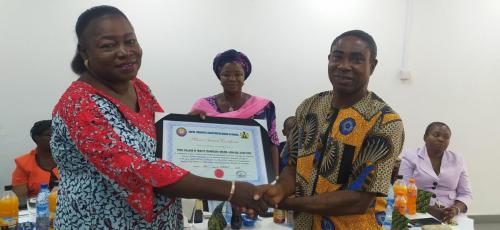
[0,185,19,230]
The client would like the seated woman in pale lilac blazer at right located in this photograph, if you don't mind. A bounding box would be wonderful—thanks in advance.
[399,122,472,222]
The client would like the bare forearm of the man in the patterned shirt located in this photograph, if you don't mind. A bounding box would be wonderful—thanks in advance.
[278,190,376,216]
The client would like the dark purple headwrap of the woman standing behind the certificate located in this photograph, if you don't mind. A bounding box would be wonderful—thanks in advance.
[213,49,252,80]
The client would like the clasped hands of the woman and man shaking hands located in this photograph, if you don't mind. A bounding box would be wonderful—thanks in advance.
[229,182,291,218]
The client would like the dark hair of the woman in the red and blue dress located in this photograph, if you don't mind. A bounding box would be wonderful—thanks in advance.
[71,5,128,74]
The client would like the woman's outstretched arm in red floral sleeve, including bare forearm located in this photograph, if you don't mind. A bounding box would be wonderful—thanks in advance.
[52,91,265,219]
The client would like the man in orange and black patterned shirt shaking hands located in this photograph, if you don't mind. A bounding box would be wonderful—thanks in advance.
[255,30,404,229]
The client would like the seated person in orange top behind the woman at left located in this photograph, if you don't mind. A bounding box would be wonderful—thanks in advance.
[12,120,59,204]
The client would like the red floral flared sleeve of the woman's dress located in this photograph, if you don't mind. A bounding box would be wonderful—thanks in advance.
[55,88,188,221]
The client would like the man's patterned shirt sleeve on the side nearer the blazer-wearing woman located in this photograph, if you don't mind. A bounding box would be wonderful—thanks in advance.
[349,117,404,196]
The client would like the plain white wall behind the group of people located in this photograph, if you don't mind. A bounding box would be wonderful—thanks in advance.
[0,0,500,214]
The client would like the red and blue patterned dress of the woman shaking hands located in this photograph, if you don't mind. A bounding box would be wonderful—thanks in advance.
[51,79,188,229]
